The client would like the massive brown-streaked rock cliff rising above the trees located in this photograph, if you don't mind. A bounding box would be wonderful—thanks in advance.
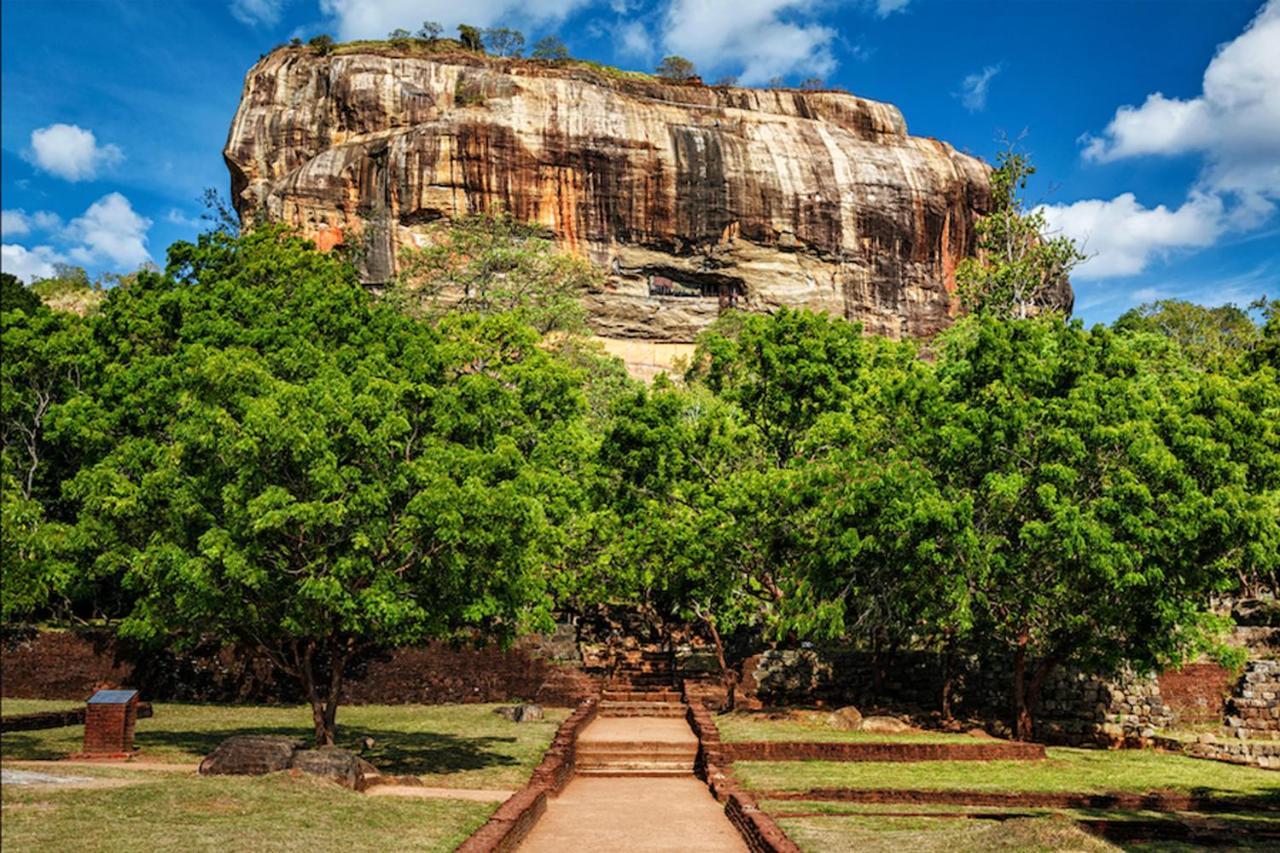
[224,49,1070,342]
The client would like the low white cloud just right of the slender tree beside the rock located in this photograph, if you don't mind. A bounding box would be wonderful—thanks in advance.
[1042,192,1229,280]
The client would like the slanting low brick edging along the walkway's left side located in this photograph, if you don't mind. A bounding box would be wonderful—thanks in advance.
[457,698,598,853]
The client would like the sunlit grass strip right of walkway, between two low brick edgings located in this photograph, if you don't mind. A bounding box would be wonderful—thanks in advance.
[733,748,1280,800]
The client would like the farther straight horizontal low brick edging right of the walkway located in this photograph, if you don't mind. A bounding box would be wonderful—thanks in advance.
[724,740,1044,761]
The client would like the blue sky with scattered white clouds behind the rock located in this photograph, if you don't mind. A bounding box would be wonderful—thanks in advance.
[0,0,1280,323]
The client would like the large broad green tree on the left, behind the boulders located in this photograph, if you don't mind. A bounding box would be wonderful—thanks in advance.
[69,228,582,744]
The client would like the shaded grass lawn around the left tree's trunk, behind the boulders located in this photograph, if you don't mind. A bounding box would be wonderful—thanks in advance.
[0,699,568,788]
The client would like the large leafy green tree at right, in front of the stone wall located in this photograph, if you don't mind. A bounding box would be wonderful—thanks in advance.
[913,315,1280,738]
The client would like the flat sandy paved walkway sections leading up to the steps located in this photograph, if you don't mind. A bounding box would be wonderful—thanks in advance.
[520,717,746,853]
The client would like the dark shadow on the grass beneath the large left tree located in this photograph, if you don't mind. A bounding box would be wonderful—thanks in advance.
[128,726,521,776]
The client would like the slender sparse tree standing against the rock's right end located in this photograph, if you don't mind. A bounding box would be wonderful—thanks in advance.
[956,145,1084,319]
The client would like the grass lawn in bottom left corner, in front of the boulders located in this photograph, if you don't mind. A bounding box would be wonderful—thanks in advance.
[0,772,494,853]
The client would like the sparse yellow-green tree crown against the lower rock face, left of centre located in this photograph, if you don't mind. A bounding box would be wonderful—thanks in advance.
[390,214,602,334]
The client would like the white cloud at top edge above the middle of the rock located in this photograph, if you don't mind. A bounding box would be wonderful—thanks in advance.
[663,0,836,86]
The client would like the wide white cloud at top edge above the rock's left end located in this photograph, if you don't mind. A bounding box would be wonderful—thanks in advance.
[320,0,589,40]
